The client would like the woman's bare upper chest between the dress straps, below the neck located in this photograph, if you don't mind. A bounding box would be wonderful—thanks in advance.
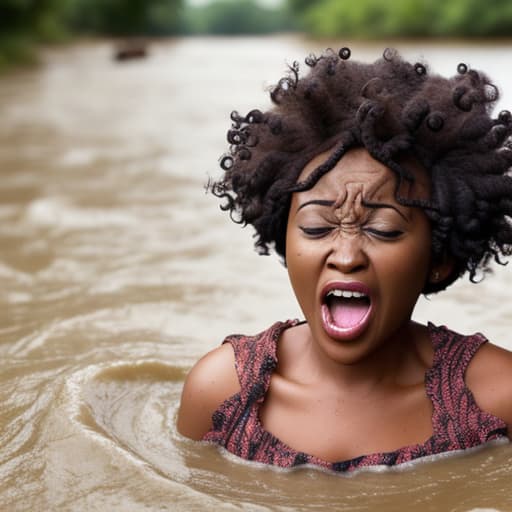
[259,373,433,462]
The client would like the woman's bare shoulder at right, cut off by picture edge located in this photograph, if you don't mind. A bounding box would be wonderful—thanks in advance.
[466,343,512,429]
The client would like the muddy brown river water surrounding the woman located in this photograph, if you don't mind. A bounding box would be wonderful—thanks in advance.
[0,36,512,512]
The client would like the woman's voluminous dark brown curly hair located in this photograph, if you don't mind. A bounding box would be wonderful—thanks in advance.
[209,48,512,293]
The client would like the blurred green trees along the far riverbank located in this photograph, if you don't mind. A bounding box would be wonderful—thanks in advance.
[0,0,512,69]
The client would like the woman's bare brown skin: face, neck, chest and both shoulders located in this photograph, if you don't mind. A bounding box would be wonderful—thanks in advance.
[178,149,512,462]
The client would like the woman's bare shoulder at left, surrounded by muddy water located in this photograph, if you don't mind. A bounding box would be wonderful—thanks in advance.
[177,343,240,440]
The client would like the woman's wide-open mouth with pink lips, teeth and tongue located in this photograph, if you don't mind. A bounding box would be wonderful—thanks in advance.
[322,286,371,338]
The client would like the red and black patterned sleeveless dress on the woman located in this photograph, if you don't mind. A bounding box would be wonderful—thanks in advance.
[203,320,507,471]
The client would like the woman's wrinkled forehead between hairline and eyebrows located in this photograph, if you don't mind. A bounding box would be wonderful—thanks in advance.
[299,148,429,200]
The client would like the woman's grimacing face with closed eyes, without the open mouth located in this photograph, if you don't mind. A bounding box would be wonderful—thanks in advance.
[286,149,431,365]
